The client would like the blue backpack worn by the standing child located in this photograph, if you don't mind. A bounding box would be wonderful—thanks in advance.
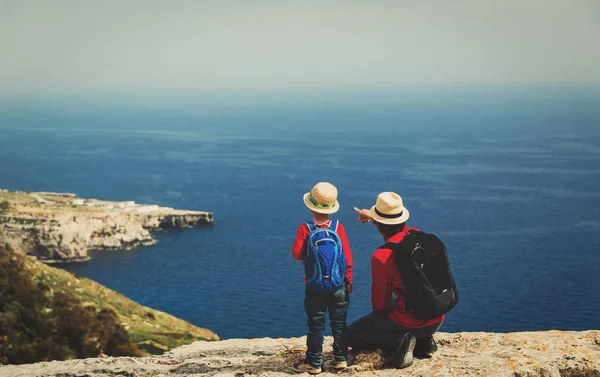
[303,221,346,293]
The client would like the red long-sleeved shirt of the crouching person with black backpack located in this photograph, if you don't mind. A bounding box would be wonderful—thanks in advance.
[371,227,444,328]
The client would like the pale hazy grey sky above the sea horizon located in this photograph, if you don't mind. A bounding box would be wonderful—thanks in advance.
[0,0,600,95]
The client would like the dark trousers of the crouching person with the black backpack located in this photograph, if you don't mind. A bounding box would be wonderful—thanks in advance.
[348,311,442,351]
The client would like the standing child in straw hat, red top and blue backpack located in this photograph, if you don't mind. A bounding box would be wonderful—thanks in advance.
[292,182,352,374]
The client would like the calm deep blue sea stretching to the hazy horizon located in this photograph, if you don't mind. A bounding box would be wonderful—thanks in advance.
[0,92,600,338]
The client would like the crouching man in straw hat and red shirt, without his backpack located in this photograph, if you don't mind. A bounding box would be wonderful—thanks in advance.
[348,192,444,368]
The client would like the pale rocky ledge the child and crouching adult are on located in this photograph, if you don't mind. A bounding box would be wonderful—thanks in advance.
[0,331,600,377]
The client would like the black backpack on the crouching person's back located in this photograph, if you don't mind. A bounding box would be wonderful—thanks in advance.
[381,231,458,320]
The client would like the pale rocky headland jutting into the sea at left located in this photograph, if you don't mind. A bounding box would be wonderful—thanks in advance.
[0,190,214,263]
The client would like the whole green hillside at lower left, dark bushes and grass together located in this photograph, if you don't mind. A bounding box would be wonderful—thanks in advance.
[0,246,219,363]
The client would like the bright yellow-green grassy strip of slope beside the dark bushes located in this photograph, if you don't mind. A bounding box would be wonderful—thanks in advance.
[26,254,219,354]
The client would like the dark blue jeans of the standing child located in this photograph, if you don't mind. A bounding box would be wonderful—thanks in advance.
[304,285,350,367]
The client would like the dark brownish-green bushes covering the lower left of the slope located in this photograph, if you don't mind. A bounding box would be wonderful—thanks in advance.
[0,247,141,364]
